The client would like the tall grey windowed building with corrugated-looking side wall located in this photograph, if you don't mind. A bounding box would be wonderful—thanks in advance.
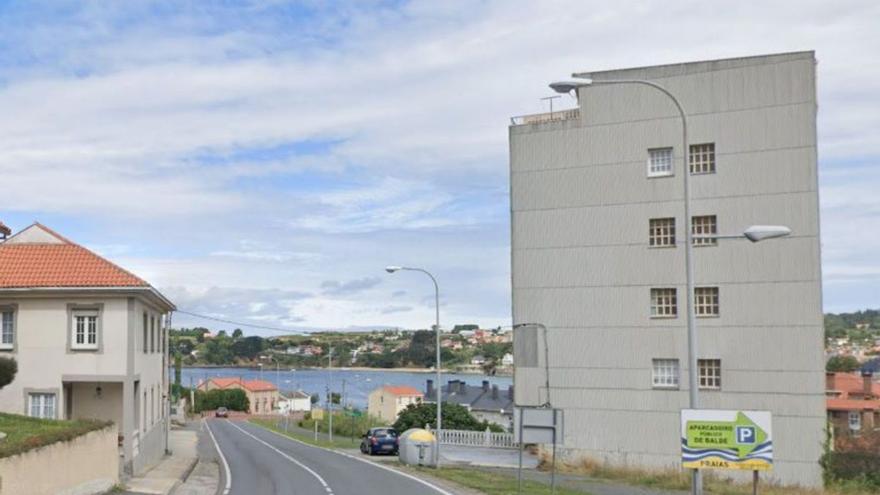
[510,52,825,486]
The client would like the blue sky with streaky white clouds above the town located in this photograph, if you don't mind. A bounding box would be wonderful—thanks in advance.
[0,0,880,336]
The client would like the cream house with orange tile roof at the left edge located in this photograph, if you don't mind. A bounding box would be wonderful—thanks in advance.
[0,223,175,473]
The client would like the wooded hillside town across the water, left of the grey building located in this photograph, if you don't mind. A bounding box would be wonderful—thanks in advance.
[170,325,513,375]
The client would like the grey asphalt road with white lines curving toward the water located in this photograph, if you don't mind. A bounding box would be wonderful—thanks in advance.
[207,419,451,495]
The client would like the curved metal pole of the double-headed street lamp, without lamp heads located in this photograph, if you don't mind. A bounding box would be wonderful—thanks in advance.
[592,79,703,495]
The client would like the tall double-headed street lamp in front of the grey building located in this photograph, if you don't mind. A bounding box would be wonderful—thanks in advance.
[550,78,791,495]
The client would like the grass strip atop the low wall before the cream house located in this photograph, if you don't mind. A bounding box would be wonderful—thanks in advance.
[0,413,111,457]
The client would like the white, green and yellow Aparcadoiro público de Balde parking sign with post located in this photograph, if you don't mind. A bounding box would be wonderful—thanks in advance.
[681,409,773,494]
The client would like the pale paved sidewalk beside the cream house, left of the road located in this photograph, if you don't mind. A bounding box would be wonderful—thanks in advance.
[124,428,199,495]
